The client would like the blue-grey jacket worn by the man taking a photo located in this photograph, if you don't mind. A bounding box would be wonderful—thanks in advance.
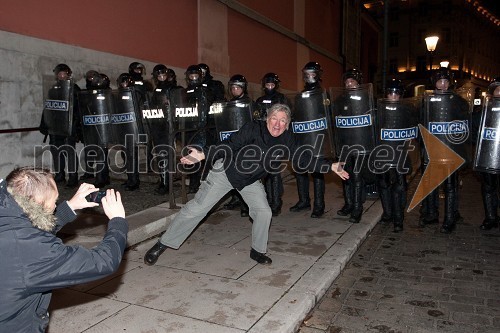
[0,181,128,333]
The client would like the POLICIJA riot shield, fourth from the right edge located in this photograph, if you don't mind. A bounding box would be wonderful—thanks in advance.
[330,83,375,158]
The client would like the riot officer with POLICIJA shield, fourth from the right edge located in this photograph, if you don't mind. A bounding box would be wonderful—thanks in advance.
[333,68,375,223]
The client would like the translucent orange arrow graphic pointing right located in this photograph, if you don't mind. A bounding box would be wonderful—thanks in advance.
[408,124,465,212]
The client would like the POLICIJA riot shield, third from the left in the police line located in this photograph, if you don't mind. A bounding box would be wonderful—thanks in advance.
[110,87,147,145]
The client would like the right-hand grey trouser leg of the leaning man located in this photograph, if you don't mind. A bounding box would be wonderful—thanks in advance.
[239,181,272,263]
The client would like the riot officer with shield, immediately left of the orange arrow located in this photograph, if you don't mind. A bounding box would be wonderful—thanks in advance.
[374,79,417,232]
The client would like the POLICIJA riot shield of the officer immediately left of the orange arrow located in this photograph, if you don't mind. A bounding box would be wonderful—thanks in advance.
[374,98,419,168]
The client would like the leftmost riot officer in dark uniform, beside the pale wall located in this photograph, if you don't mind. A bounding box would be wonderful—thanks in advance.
[40,64,81,187]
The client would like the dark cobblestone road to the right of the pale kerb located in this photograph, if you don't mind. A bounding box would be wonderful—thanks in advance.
[299,172,500,333]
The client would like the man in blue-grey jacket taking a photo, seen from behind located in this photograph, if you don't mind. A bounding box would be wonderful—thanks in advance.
[0,167,128,332]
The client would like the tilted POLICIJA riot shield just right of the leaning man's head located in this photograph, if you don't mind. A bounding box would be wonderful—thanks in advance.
[287,89,333,158]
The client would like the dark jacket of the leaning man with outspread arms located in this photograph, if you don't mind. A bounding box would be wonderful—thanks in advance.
[205,120,331,190]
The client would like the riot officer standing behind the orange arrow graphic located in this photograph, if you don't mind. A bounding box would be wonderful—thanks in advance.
[419,67,470,234]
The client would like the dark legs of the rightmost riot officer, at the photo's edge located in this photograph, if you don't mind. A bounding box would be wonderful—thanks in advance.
[480,172,498,230]
